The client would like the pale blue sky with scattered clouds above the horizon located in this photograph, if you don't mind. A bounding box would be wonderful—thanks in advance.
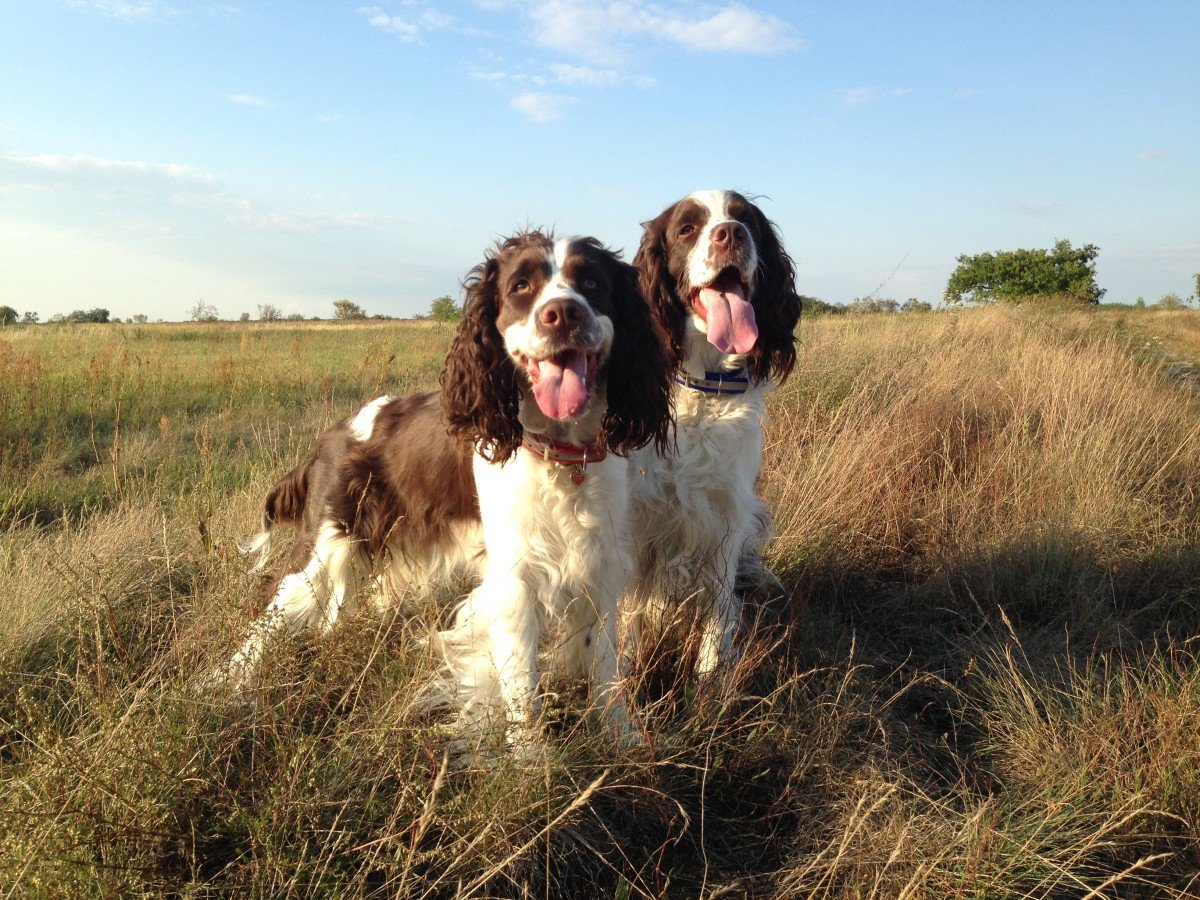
[0,0,1200,320]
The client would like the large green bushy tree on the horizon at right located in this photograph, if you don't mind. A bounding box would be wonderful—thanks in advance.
[946,240,1105,304]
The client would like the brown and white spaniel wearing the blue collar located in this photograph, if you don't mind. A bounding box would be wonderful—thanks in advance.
[629,191,800,676]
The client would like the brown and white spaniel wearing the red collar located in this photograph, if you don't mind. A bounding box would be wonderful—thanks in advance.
[228,232,670,742]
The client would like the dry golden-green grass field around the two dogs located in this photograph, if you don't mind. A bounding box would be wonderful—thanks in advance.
[0,307,1200,898]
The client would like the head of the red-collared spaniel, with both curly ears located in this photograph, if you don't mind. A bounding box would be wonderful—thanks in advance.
[442,232,671,461]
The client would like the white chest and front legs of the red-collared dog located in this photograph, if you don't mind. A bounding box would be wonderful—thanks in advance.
[439,451,632,743]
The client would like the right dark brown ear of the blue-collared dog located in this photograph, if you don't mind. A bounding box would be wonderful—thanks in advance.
[749,204,800,384]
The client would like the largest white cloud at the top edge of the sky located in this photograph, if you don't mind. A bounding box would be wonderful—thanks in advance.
[520,0,800,64]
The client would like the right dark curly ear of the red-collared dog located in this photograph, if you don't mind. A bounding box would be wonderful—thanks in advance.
[602,254,672,456]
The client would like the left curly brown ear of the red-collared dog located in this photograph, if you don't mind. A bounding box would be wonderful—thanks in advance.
[442,256,521,462]
